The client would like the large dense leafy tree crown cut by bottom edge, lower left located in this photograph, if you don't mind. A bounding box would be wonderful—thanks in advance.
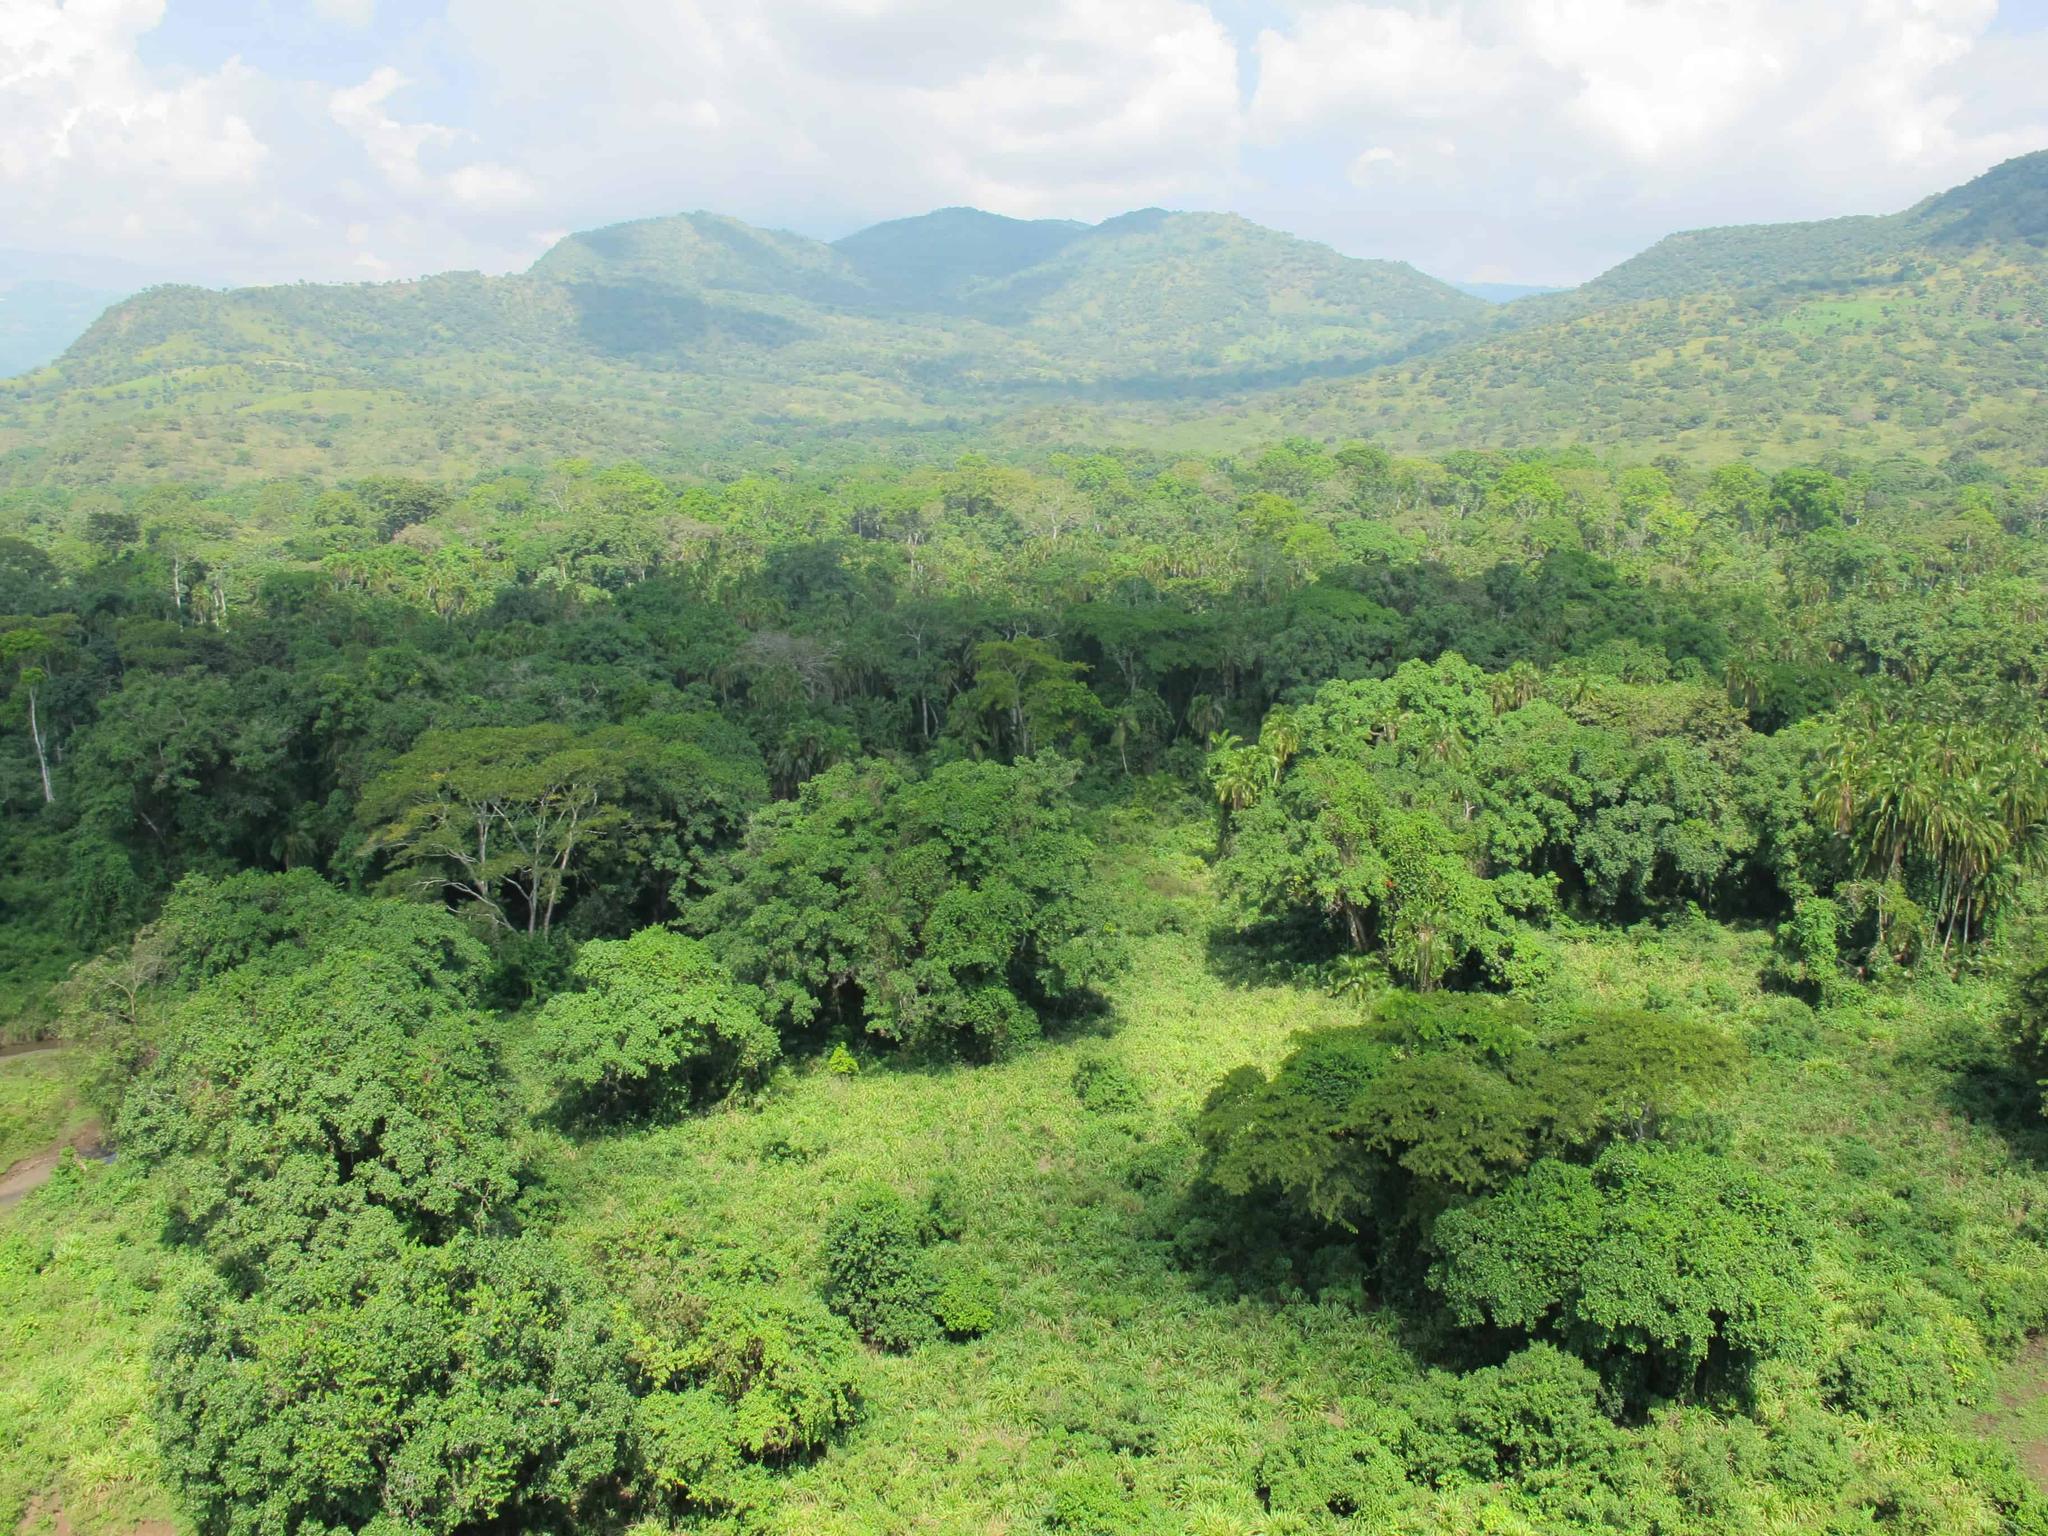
[154,1221,635,1536]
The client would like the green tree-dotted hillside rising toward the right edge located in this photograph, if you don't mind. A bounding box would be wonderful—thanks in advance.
[1286,152,2048,461]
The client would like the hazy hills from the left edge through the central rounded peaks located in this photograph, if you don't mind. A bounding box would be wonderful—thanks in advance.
[0,209,1491,481]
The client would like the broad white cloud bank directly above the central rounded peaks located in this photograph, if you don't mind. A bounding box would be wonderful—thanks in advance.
[449,0,1241,227]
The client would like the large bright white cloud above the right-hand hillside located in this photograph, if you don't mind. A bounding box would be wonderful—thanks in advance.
[1247,0,2048,279]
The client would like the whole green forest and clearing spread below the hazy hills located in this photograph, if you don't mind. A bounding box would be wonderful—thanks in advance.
[0,440,2048,1536]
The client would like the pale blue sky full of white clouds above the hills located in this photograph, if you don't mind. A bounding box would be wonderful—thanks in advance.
[0,0,2048,285]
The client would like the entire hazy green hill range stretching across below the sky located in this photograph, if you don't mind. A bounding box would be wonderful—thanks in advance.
[0,154,2048,483]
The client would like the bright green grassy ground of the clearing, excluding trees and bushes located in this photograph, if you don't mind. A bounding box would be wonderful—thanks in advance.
[12,847,2048,1536]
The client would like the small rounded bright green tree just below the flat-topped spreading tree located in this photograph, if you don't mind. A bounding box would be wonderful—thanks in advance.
[532,928,780,1112]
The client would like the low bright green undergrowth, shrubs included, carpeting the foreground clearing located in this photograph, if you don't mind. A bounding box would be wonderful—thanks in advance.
[12,847,2048,1532]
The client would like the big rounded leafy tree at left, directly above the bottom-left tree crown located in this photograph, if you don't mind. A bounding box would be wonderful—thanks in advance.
[115,937,516,1282]
